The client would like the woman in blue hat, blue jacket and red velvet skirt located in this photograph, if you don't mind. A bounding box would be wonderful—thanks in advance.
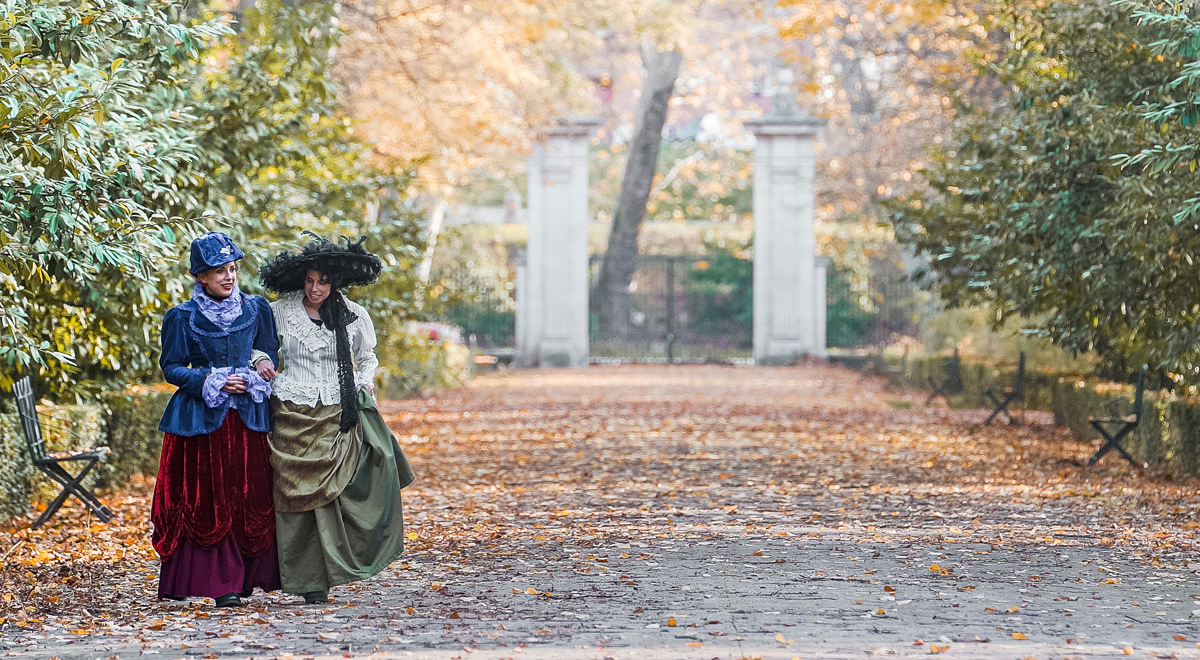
[150,232,280,607]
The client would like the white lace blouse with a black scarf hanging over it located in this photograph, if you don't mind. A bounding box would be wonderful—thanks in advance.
[251,292,379,406]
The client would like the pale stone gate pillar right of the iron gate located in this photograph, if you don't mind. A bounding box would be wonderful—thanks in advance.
[748,103,826,365]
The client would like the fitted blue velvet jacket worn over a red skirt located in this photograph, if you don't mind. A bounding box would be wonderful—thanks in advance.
[158,294,280,436]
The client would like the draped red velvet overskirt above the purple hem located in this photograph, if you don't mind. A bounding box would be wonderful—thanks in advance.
[150,410,275,560]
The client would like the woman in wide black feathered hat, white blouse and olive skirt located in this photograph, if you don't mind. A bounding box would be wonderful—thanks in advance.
[254,236,413,602]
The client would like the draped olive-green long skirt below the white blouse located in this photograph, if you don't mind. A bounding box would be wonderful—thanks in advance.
[271,391,413,594]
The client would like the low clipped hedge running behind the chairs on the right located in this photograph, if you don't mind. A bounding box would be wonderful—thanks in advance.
[859,354,1200,476]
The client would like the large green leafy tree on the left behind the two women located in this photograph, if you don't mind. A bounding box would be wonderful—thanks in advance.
[0,0,419,394]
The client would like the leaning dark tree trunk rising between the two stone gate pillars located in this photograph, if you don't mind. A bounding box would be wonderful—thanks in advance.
[592,44,683,337]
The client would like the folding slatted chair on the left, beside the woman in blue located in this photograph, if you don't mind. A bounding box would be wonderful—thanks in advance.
[12,376,113,529]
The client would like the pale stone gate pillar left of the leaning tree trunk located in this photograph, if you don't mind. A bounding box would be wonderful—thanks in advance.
[515,119,599,367]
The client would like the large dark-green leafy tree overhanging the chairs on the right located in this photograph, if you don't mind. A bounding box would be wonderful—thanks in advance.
[895,0,1200,384]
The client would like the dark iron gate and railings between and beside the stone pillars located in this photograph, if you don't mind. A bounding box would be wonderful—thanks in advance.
[439,254,936,362]
